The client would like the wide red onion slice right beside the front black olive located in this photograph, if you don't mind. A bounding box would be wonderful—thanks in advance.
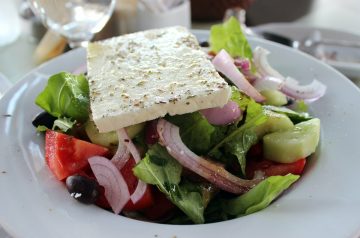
[88,156,130,214]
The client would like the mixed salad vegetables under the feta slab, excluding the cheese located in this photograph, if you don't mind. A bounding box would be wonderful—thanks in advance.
[33,18,326,224]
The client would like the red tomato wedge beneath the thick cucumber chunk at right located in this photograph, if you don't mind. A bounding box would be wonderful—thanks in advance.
[246,159,306,178]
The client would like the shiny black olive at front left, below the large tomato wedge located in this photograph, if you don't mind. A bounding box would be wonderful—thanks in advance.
[66,175,100,204]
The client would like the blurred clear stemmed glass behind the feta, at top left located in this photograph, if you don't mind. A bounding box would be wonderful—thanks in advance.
[29,0,116,48]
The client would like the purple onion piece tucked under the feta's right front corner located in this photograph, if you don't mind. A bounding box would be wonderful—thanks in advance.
[200,101,242,125]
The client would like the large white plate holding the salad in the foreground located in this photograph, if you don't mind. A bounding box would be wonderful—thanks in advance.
[0,34,360,238]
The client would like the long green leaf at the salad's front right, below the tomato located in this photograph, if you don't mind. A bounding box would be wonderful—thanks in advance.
[223,174,300,216]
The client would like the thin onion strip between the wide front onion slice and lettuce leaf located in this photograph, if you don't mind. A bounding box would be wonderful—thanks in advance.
[117,128,147,204]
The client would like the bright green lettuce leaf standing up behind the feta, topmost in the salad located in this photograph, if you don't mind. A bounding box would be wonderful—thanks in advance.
[210,17,252,59]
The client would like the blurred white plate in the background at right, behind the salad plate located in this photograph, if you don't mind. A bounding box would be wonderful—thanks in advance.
[252,23,360,78]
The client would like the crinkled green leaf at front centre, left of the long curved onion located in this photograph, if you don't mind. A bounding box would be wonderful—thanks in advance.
[133,144,205,223]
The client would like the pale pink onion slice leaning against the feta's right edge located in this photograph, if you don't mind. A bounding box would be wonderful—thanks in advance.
[212,50,265,102]
